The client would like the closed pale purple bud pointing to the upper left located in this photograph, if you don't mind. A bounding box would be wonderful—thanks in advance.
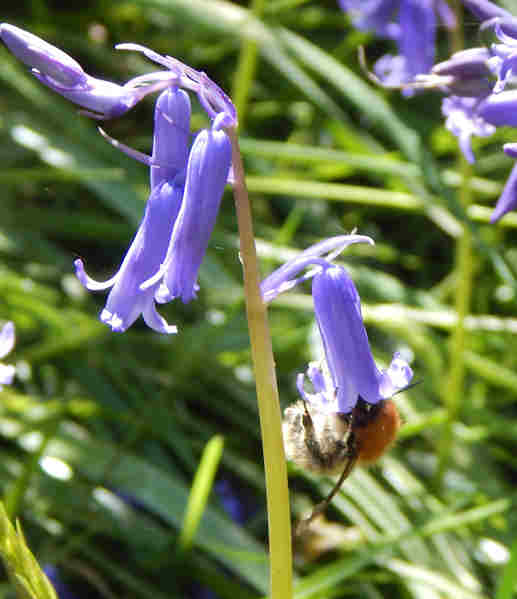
[0,23,175,119]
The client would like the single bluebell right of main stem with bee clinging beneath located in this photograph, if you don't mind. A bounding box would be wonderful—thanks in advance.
[262,235,413,414]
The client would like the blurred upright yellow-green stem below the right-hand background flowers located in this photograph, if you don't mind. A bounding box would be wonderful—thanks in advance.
[435,0,474,488]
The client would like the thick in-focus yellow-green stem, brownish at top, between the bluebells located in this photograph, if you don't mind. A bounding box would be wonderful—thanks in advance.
[228,129,292,599]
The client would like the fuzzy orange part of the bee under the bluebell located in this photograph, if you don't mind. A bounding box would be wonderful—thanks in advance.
[356,399,400,464]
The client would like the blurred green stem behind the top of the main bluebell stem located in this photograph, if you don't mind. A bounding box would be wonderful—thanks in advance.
[232,0,266,128]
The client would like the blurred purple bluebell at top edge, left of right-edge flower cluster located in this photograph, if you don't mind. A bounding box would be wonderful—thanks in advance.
[339,0,456,95]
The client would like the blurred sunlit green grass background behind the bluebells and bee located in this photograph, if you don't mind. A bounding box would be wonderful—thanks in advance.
[0,0,517,599]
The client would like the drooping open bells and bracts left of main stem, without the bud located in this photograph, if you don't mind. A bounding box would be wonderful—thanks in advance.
[70,51,232,333]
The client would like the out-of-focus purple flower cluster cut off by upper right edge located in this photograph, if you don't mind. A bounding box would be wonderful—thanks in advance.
[432,0,517,222]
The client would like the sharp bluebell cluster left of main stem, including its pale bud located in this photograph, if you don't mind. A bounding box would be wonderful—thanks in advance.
[0,24,237,333]
